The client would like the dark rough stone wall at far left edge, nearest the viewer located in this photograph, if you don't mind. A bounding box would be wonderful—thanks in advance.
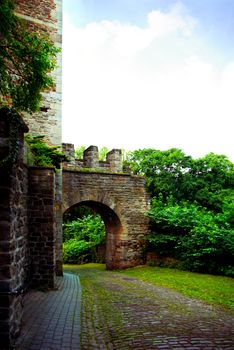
[0,110,29,349]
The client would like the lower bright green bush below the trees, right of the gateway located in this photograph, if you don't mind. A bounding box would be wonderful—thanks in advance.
[148,200,234,276]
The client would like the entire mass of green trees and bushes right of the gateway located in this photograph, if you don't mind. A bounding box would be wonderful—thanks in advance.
[128,148,234,275]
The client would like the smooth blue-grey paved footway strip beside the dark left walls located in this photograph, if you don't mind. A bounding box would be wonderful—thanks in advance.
[17,274,81,350]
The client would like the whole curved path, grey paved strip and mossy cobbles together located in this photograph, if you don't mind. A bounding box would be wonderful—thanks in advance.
[19,268,234,350]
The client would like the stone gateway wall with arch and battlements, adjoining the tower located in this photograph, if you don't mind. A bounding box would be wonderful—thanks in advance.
[62,144,148,269]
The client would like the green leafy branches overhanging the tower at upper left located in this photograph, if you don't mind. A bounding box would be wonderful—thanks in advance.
[0,0,59,112]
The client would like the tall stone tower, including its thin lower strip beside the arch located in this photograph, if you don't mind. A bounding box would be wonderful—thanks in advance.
[15,0,62,275]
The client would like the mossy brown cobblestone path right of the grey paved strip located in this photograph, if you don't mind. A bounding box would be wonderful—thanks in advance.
[66,269,234,350]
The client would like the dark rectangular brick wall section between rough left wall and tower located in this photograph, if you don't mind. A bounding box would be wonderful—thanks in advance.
[28,167,55,288]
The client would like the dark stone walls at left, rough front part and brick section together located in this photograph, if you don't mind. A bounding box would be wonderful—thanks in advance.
[0,109,57,349]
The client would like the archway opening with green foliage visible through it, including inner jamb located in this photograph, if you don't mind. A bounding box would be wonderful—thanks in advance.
[63,201,122,269]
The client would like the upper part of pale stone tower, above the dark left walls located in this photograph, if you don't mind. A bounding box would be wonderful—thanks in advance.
[15,0,62,146]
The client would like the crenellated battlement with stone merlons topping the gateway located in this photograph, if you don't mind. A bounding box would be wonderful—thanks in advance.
[63,143,123,173]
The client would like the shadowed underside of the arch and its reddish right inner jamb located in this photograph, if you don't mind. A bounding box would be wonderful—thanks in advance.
[64,200,124,269]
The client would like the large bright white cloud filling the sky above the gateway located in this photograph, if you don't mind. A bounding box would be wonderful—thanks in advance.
[63,3,234,157]
